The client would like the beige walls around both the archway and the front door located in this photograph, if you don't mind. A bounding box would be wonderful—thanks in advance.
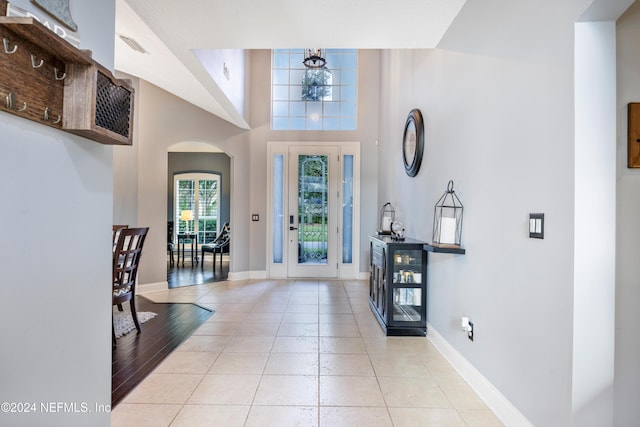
[114,50,379,286]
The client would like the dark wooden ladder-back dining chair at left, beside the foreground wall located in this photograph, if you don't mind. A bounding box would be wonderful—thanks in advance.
[111,227,149,346]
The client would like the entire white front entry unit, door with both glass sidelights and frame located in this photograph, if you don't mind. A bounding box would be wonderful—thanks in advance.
[267,142,360,278]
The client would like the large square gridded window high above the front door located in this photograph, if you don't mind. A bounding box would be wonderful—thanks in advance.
[271,49,358,130]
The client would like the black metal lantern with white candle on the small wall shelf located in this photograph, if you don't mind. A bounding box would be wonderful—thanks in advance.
[433,180,463,247]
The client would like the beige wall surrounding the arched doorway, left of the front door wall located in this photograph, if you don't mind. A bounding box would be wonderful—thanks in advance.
[114,81,251,286]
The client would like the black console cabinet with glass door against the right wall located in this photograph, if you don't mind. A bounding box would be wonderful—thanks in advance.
[369,236,427,336]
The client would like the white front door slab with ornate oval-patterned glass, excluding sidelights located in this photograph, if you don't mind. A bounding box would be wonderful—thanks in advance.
[286,146,340,278]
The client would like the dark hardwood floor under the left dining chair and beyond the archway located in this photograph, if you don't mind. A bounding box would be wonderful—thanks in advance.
[111,255,229,408]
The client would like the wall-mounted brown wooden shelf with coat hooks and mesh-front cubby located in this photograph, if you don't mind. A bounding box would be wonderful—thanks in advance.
[0,0,135,145]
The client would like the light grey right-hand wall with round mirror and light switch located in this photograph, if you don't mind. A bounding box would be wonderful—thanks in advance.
[380,0,640,426]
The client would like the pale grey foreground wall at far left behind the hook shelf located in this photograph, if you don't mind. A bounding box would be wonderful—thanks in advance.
[0,0,115,426]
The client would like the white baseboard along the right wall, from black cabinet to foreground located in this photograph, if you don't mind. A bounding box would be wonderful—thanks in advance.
[427,323,534,427]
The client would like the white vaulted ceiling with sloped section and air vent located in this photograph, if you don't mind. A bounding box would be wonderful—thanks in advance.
[115,0,466,128]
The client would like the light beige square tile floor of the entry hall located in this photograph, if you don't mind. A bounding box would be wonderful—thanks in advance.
[111,280,502,427]
